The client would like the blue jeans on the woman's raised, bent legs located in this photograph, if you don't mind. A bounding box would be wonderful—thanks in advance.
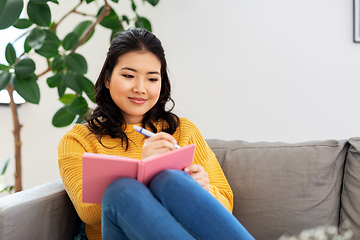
[101,170,254,240]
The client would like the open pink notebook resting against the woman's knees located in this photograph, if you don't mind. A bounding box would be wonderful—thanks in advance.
[82,144,195,204]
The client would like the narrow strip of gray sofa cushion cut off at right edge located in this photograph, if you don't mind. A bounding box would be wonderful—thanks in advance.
[340,138,360,239]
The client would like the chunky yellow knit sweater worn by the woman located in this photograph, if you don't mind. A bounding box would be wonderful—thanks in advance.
[58,118,233,240]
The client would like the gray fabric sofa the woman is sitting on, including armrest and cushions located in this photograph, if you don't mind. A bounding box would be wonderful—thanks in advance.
[0,138,360,240]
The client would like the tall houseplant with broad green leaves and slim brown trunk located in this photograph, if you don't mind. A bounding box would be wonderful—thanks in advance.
[0,0,159,192]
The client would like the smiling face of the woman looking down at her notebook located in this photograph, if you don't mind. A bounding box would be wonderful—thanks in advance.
[105,52,161,124]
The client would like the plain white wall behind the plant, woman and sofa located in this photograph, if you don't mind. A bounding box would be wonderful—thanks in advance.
[0,0,360,191]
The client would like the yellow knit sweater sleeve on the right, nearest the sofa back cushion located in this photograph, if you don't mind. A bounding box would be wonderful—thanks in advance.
[182,120,233,212]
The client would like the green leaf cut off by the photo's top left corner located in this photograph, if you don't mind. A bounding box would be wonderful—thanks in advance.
[0,0,24,30]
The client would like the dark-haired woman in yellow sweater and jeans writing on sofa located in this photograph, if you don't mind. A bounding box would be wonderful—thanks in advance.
[58,28,253,240]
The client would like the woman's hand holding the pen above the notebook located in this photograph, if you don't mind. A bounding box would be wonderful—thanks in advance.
[142,132,176,159]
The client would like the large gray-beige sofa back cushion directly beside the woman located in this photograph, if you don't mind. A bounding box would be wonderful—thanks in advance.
[208,140,348,240]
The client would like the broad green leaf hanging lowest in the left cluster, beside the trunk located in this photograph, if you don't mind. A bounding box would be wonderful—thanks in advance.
[13,74,40,104]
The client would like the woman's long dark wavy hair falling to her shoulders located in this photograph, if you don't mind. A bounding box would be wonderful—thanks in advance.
[87,28,179,149]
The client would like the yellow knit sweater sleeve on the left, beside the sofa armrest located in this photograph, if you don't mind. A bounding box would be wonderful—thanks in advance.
[58,128,101,225]
